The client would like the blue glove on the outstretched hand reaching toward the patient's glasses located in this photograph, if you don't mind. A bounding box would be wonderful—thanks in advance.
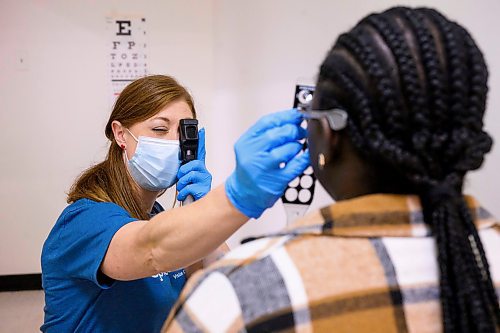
[226,109,310,218]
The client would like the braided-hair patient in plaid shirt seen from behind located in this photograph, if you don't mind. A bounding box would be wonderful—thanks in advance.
[163,7,500,333]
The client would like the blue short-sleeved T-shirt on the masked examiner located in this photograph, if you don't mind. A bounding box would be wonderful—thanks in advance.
[40,199,186,333]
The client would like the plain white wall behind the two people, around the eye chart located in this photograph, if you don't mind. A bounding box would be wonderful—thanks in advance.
[0,0,500,275]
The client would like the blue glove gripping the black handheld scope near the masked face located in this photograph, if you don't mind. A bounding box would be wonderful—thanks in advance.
[177,128,212,201]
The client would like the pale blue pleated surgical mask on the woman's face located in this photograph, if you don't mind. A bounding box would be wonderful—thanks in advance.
[125,129,181,191]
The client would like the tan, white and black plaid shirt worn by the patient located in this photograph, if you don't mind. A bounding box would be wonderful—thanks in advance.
[162,194,500,333]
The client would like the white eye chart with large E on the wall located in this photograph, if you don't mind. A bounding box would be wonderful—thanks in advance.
[106,17,148,102]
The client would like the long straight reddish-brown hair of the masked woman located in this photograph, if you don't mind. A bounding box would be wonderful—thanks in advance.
[67,75,196,220]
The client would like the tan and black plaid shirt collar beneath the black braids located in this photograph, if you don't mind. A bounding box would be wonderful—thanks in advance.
[288,194,498,237]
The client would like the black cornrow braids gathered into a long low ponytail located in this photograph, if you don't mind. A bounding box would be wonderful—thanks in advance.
[317,7,500,332]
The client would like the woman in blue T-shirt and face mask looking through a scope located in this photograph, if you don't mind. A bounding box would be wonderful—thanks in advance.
[41,75,308,332]
